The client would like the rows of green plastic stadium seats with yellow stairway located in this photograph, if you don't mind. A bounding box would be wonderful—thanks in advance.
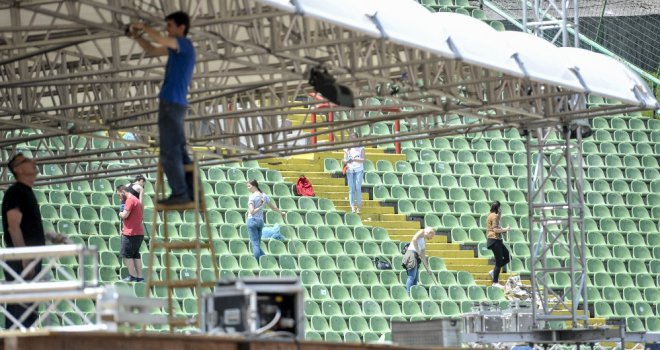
[0,0,660,336]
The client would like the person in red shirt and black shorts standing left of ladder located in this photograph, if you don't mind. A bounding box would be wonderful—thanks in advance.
[119,189,144,282]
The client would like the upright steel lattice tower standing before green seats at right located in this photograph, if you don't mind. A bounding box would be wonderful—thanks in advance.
[527,127,589,328]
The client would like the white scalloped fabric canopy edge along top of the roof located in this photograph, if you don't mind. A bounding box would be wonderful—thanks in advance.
[261,0,658,108]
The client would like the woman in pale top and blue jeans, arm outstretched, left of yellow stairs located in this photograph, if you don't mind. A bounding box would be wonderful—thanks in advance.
[247,180,286,261]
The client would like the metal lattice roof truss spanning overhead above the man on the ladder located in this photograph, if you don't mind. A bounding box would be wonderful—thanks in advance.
[0,0,656,184]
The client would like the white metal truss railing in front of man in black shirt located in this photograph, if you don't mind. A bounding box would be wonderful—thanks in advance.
[0,244,103,334]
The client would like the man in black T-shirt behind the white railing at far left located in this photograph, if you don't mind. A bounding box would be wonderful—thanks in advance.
[2,153,46,329]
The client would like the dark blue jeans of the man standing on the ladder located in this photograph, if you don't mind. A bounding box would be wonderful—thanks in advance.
[158,100,193,196]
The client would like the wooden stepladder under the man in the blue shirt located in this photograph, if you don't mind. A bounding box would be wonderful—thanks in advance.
[146,157,219,331]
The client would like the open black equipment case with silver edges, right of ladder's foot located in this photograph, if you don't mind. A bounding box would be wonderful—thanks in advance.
[202,278,305,339]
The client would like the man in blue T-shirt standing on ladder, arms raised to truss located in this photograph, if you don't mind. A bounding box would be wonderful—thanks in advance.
[129,11,195,205]
